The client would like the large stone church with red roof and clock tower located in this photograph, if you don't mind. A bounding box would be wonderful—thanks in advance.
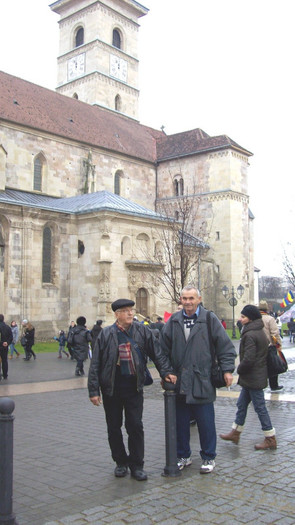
[0,0,254,338]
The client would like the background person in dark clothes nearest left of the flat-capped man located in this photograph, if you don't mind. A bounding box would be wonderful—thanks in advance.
[68,316,92,376]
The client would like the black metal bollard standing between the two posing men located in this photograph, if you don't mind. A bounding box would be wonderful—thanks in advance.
[162,381,181,477]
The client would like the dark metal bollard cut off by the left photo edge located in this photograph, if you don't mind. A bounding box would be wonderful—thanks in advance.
[0,397,16,525]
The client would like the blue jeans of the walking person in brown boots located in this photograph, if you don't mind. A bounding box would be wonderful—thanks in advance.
[235,387,273,430]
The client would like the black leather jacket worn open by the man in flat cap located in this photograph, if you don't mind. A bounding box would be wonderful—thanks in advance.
[88,323,173,397]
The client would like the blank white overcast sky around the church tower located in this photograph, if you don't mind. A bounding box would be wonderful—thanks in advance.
[0,0,295,275]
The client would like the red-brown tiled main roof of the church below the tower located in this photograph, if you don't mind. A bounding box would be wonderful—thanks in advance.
[0,72,251,163]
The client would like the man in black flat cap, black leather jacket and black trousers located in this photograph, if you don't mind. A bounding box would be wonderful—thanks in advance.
[88,299,176,481]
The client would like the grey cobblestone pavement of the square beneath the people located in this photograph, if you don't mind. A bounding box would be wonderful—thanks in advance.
[0,342,295,525]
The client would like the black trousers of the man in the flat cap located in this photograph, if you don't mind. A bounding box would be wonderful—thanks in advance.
[103,378,144,469]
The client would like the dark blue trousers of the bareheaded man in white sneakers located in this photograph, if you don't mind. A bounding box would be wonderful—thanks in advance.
[176,396,216,459]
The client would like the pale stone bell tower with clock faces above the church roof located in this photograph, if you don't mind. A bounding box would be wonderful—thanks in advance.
[50,0,148,120]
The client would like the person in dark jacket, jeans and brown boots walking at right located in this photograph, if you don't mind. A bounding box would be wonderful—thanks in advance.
[220,304,277,450]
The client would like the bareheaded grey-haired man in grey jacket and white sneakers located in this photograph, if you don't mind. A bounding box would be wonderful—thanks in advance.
[161,286,236,474]
